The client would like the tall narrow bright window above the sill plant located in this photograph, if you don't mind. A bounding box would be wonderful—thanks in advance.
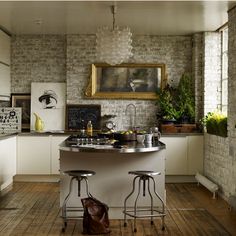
[221,26,228,115]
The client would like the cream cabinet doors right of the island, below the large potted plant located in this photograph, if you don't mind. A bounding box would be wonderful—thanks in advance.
[160,135,203,175]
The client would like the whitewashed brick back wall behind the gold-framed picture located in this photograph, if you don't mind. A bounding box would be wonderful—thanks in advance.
[11,35,192,129]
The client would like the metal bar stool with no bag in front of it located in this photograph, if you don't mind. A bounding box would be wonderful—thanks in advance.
[123,171,166,232]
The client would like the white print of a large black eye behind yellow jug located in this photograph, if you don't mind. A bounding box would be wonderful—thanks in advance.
[30,83,66,131]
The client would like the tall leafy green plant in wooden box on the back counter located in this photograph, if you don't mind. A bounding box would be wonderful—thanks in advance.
[157,74,196,133]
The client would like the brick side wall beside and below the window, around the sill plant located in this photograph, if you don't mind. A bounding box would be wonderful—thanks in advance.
[203,32,230,196]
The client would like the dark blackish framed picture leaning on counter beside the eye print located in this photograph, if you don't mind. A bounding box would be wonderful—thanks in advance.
[65,104,101,131]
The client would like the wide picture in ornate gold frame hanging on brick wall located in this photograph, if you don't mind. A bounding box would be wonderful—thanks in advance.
[86,64,166,99]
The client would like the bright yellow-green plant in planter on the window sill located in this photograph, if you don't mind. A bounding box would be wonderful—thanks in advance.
[201,111,227,137]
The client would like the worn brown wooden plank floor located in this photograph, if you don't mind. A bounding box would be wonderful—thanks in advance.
[0,183,236,236]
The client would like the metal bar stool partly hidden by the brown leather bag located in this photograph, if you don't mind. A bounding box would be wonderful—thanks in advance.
[62,170,96,232]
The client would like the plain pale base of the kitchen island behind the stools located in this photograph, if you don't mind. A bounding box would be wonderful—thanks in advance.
[60,149,165,219]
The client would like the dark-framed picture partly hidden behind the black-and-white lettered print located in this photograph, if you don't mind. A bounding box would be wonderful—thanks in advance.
[11,93,31,130]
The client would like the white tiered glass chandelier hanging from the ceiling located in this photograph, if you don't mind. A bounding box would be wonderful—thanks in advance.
[96,6,133,65]
